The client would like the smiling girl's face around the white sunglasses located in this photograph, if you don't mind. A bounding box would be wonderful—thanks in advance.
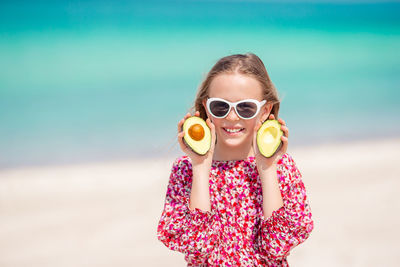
[203,73,272,155]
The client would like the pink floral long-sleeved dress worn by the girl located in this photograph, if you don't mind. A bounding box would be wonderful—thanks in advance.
[157,153,314,266]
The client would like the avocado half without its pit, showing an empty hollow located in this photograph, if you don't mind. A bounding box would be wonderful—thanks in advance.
[257,120,283,158]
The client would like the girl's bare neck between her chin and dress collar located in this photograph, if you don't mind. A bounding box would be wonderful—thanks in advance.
[213,140,254,160]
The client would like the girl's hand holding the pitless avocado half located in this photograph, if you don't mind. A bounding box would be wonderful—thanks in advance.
[253,114,289,171]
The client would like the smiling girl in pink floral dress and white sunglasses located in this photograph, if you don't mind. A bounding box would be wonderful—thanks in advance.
[157,53,313,266]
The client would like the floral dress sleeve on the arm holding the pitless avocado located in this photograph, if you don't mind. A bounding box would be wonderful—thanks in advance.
[259,154,314,260]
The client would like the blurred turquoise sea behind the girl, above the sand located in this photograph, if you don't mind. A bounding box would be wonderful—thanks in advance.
[0,0,400,168]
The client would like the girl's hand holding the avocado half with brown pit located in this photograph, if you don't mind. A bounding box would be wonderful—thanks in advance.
[178,111,216,166]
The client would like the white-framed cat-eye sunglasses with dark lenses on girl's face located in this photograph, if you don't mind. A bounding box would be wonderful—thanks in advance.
[207,97,267,120]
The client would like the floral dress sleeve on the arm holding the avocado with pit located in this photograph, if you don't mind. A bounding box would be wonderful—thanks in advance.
[157,157,217,265]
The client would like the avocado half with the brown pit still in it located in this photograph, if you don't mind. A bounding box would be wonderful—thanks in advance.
[183,116,211,155]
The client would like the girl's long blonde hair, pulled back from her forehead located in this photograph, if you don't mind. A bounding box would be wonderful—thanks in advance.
[192,53,280,120]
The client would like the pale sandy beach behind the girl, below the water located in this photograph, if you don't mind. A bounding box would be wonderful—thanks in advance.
[0,138,400,267]
